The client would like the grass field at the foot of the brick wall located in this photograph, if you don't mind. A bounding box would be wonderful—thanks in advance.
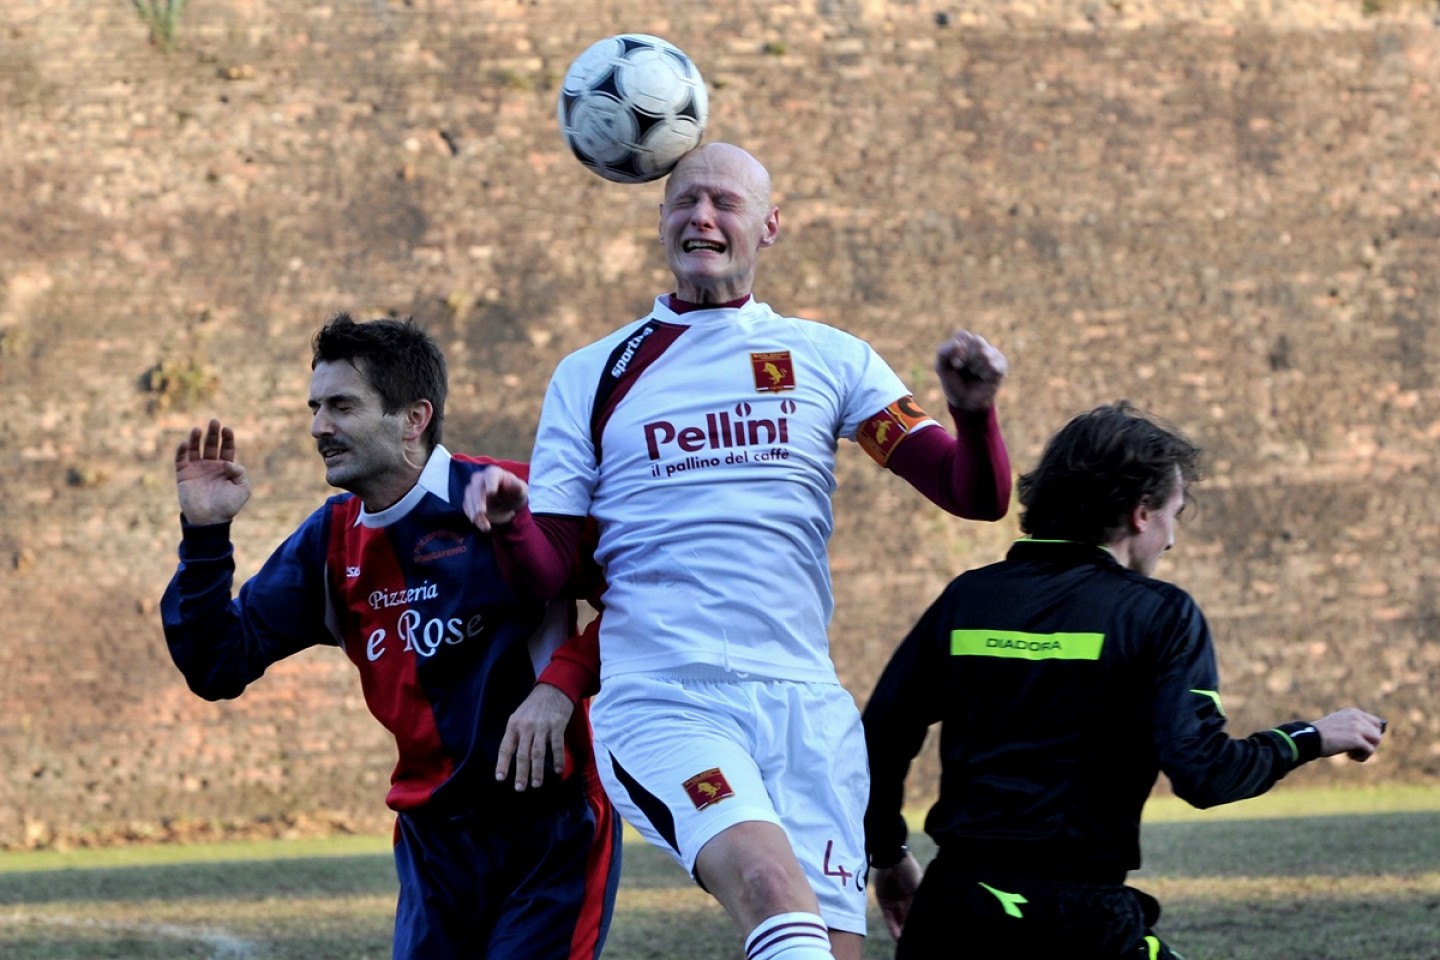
[0,789,1440,960]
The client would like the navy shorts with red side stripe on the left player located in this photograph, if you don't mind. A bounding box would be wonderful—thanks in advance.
[395,774,621,960]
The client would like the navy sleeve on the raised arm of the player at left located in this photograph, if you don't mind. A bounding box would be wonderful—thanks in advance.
[160,510,336,699]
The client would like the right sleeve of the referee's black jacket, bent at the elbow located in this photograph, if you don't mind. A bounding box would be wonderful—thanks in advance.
[1152,602,1300,809]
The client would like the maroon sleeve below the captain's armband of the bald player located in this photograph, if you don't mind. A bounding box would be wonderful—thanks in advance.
[886,407,1011,520]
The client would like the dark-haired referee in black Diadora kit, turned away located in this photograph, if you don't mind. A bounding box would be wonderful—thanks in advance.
[864,402,1384,960]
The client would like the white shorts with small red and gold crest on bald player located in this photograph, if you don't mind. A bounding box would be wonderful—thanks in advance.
[590,674,870,934]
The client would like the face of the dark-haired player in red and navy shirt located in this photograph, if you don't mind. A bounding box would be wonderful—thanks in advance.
[310,360,413,510]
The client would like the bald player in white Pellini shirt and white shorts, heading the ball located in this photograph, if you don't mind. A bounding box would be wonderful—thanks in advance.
[465,144,1011,960]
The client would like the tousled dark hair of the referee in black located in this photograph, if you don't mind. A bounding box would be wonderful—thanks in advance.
[1018,400,1201,544]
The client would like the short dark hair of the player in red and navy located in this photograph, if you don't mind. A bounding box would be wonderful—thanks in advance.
[310,314,449,452]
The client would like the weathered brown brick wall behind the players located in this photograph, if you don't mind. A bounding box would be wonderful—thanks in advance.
[0,0,1440,845]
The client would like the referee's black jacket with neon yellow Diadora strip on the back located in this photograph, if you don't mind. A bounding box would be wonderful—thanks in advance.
[864,540,1319,882]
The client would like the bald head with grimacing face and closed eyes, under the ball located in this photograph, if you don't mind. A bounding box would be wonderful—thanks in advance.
[660,144,780,304]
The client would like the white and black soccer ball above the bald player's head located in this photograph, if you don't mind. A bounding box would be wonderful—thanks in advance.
[556,33,710,183]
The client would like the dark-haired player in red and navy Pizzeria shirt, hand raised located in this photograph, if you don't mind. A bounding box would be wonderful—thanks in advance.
[161,314,621,960]
